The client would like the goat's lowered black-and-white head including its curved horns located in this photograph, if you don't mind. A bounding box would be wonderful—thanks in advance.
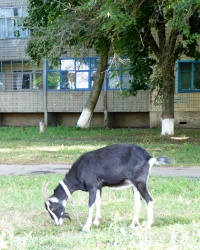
[42,183,70,226]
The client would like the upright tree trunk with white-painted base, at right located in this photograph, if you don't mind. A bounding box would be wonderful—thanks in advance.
[161,60,175,135]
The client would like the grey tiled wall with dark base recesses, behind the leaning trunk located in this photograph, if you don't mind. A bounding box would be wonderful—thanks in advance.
[0,91,149,127]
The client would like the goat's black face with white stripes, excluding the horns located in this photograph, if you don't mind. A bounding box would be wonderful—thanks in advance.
[45,197,67,226]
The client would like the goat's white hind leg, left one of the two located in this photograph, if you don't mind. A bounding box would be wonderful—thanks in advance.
[130,187,142,228]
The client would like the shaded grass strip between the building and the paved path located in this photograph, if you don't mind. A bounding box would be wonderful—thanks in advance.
[0,126,200,166]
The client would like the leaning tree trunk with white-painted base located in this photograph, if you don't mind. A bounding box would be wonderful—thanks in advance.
[77,48,109,128]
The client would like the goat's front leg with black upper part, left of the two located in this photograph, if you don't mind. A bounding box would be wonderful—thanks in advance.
[82,188,97,233]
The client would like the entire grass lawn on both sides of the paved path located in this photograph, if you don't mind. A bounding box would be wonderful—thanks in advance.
[0,126,200,250]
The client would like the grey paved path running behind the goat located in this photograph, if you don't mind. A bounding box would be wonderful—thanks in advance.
[0,164,200,178]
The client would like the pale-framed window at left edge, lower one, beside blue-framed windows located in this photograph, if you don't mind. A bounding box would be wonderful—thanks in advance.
[0,61,43,91]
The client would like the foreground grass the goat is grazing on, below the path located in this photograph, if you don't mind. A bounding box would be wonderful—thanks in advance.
[0,174,200,250]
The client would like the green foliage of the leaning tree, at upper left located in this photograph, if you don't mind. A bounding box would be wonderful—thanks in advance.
[24,0,109,63]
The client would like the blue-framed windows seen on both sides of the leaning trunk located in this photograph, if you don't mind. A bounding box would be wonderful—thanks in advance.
[47,57,130,91]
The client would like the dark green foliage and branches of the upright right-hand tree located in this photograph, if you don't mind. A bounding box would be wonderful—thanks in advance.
[96,0,200,95]
